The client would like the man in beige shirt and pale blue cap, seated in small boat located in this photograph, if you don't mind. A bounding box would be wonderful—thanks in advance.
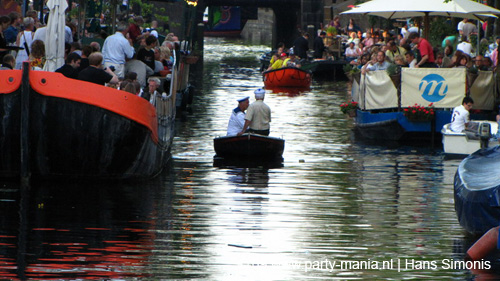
[238,89,271,136]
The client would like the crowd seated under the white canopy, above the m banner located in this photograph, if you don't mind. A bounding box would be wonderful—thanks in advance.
[340,19,500,73]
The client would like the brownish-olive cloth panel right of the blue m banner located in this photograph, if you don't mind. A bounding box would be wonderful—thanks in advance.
[470,71,495,110]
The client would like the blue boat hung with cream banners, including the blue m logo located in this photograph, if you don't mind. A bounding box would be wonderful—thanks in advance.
[351,68,495,141]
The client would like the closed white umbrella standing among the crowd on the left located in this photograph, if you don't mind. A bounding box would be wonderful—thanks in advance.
[43,0,68,71]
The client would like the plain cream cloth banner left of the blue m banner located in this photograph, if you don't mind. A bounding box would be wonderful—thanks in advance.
[361,70,398,110]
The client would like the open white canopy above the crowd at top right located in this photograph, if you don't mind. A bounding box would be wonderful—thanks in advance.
[341,0,500,20]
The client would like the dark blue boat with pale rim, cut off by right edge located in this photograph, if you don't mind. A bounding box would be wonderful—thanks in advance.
[454,146,500,235]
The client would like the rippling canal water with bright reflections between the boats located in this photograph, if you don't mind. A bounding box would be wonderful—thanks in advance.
[0,39,498,280]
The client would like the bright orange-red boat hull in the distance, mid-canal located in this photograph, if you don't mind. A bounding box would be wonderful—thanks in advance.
[263,67,312,89]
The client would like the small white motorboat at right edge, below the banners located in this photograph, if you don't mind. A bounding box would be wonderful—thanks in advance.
[441,120,498,156]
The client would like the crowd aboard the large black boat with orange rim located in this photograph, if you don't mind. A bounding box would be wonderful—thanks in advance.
[0,11,178,102]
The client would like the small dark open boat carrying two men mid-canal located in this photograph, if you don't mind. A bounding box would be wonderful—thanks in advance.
[214,134,285,160]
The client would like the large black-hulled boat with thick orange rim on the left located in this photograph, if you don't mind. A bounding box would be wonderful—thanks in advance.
[0,65,175,180]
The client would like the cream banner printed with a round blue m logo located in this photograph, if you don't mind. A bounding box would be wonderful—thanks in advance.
[401,67,466,108]
